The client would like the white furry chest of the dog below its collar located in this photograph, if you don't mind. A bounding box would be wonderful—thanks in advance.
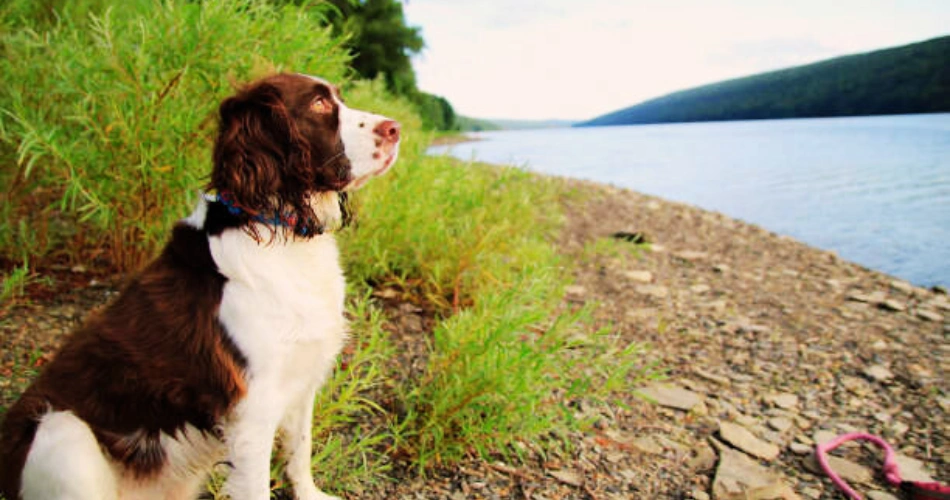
[210,231,345,379]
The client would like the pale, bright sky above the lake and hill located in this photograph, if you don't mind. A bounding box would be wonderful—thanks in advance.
[403,0,950,120]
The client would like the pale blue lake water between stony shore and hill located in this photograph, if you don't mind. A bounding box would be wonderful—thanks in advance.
[430,114,950,286]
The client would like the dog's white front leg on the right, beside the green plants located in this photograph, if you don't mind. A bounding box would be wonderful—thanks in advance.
[280,388,338,500]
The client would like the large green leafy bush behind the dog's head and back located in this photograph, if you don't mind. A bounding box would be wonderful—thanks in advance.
[0,0,349,270]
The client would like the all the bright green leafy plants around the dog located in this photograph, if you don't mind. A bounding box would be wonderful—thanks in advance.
[0,0,641,496]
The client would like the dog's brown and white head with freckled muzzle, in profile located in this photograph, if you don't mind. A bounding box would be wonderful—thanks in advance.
[210,74,400,237]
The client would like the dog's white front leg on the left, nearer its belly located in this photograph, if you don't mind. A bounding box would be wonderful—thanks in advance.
[224,393,280,500]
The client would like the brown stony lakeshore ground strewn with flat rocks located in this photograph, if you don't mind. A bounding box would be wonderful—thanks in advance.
[0,181,950,500]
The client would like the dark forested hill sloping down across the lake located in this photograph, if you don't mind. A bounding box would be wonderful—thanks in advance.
[576,36,950,126]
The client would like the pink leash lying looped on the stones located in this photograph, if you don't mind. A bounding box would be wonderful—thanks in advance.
[815,432,950,500]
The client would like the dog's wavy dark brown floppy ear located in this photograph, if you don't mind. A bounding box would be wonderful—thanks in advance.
[210,83,319,236]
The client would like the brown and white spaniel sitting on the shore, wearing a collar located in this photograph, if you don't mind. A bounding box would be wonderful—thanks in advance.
[0,74,400,500]
